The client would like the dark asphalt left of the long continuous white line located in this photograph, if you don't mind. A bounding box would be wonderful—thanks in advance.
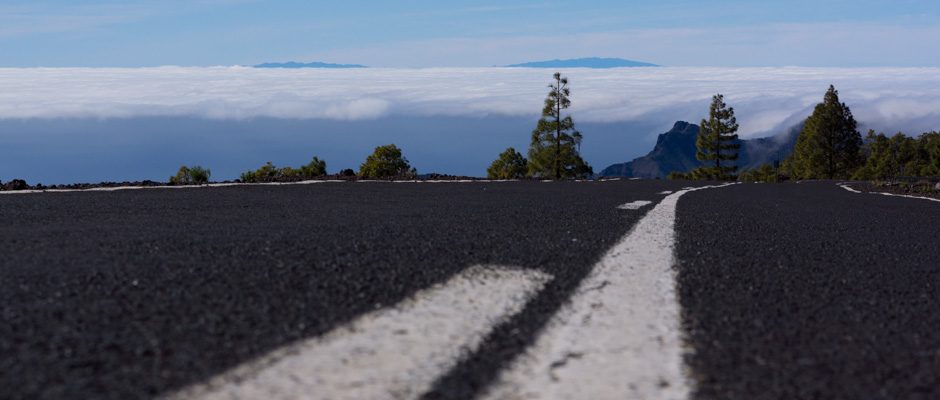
[0,181,696,399]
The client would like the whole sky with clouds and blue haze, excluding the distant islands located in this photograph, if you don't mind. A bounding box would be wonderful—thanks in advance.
[0,0,940,184]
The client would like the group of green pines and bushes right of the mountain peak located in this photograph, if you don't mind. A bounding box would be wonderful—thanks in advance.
[669,85,940,182]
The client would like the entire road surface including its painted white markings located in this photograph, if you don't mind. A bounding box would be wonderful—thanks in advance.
[0,180,940,399]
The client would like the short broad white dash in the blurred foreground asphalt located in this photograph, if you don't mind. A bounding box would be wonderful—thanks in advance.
[162,266,551,399]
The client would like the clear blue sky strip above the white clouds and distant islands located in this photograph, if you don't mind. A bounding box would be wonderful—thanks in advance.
[0,0,940,68]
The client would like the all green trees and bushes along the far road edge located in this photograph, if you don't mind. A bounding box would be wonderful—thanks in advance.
[170,72,940,184]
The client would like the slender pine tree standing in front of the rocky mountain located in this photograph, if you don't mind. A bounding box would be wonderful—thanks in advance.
[690,93,741,180]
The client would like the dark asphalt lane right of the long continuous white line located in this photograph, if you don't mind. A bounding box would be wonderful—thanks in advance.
[676,182,940,399]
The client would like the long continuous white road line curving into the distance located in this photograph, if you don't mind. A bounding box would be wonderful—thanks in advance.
[483,185,726,399]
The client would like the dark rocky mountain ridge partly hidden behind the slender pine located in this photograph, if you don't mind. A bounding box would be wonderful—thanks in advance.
[598,121,803,178]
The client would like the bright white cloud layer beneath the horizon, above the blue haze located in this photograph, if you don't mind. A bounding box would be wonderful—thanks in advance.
[0,67,940,137]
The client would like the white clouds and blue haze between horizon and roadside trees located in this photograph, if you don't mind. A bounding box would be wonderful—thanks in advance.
[0,67,940,183]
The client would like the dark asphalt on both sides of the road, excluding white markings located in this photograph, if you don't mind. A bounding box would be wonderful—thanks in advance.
[0,180,940,399]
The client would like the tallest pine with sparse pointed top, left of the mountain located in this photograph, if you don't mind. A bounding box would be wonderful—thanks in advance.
[528,72,594,179]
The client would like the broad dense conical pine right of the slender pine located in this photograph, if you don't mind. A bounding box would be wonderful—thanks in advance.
[790,85,862,179]
